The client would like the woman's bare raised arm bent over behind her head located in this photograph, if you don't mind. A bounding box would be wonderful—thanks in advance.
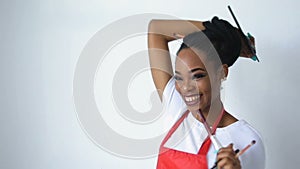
[148,20,205,100]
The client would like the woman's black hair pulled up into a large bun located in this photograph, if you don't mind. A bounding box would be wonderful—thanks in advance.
[177,17,241,67]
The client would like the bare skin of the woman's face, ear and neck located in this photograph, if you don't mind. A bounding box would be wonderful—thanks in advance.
[175,48,237,127]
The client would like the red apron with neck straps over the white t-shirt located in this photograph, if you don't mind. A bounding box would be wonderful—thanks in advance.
[156,110,224,169]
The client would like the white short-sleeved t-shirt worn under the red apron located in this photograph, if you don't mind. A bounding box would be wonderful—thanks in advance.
[163,78,265,169]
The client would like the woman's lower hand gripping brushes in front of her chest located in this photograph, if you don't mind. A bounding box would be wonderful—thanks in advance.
[217,144,241,169]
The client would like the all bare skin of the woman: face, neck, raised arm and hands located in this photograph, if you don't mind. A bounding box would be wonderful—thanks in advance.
[148,20,254,169]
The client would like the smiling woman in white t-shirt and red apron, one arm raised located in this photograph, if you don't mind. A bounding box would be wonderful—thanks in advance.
[148,17,265,169]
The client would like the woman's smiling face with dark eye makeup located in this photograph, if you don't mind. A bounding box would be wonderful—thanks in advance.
[175,48,220,112]
